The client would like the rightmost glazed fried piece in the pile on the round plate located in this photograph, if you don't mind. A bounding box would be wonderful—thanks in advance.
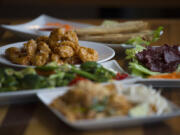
[79,47,98,62]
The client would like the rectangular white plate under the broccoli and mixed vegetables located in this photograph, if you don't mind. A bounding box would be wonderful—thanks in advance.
[0,60,132,104]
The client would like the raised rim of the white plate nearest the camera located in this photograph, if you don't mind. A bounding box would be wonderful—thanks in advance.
[36,82,180,129]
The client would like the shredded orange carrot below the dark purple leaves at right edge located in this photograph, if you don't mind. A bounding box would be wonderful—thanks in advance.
[148,72,180,79]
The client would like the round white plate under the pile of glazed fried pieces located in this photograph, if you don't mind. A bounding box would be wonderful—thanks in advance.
[0,41,115,67]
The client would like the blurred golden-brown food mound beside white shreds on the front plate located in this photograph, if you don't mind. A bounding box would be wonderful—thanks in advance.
[50,81,132,122]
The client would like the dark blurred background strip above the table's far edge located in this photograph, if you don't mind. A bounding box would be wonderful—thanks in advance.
[0,0,180,19]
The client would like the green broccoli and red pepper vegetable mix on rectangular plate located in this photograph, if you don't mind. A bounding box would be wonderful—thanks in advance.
[0,61,128,92]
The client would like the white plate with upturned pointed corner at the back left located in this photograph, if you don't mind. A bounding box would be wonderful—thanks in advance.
[1,15,92,38]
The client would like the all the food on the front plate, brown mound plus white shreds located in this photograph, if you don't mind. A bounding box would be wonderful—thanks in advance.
[50,80,171,122]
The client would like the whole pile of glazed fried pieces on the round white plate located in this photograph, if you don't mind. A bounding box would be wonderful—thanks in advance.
[5,29,98,66]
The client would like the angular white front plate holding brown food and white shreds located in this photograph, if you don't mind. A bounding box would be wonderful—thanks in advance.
[37,84,180,130]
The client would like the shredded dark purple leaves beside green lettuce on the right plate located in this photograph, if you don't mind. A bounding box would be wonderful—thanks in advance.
[136,44,180,73]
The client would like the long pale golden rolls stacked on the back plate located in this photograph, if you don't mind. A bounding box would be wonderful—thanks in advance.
[75,20,162,44]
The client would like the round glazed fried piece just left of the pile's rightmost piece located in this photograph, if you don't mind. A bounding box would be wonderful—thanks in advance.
[55,46,74,58]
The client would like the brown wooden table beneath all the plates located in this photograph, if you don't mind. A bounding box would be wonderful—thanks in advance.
[0,19,180,135]
